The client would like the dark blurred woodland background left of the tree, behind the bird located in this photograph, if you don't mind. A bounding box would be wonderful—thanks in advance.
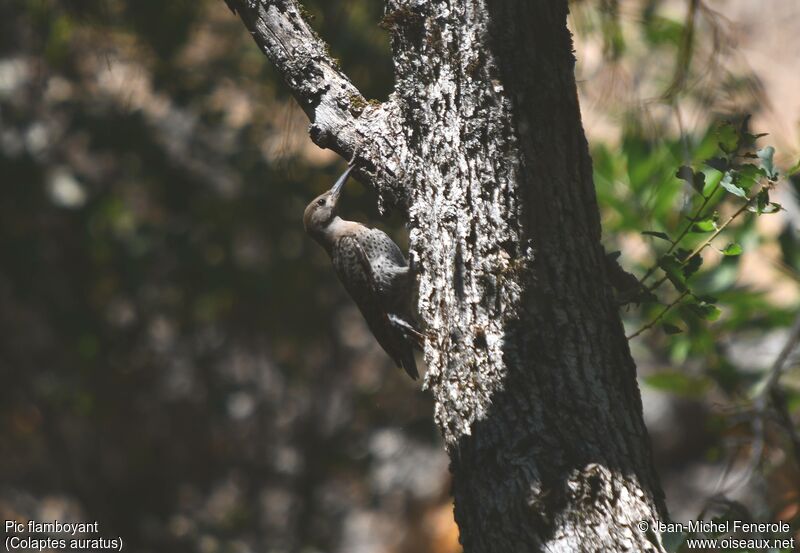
[0,1,448,551]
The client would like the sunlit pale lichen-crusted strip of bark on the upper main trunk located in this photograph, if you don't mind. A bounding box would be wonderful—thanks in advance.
[387,2,533,446]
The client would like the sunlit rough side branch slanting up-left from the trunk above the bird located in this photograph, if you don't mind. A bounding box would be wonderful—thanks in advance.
[225,0,406,207]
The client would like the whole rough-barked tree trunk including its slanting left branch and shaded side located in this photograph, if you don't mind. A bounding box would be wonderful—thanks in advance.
[227,0,666,553]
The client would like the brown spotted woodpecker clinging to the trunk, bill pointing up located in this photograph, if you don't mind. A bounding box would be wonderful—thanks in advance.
[303,167,422,379]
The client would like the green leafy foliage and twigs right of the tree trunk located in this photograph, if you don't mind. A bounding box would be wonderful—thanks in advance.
[593,113,800,551]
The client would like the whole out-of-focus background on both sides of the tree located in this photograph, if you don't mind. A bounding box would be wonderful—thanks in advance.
[0,0,800,553]
